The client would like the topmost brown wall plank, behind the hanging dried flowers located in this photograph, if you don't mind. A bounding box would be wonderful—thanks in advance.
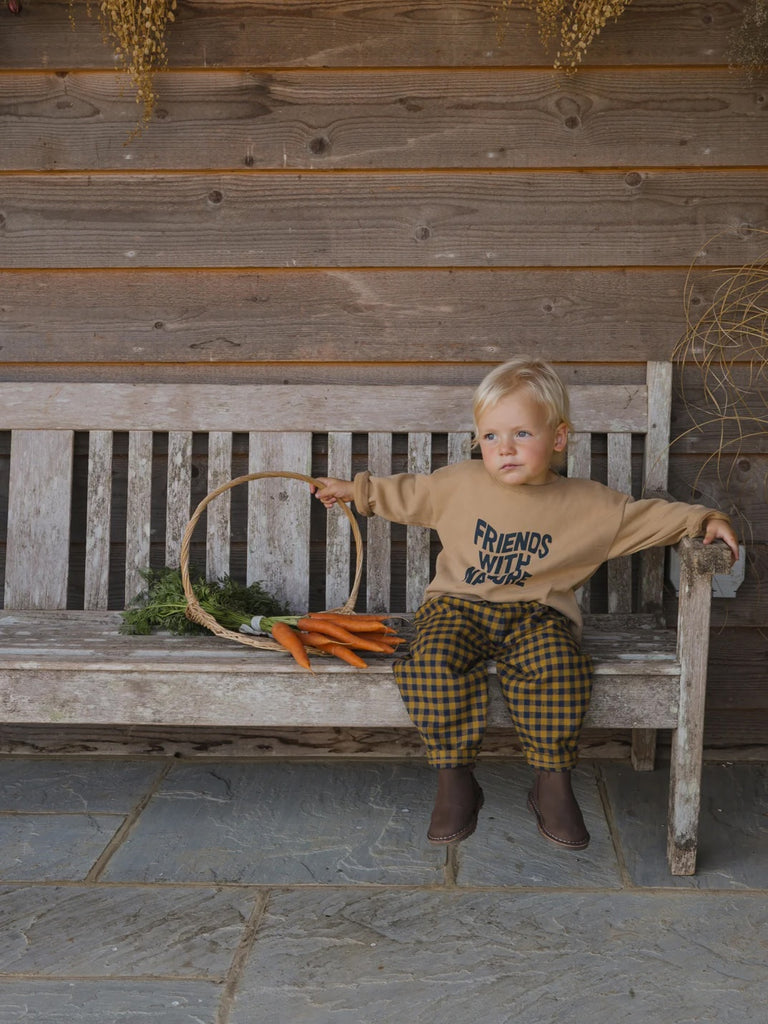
[3,0,741,69]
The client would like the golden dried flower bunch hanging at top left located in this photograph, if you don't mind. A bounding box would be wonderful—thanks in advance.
[88,0,176,130]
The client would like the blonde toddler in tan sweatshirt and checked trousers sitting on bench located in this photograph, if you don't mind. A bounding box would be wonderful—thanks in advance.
[316,357,738,850]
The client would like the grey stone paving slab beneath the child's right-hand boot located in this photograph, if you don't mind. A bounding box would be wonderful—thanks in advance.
[457,761,622,888]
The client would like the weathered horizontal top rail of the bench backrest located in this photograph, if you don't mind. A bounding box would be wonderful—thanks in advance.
[0,382,647,433]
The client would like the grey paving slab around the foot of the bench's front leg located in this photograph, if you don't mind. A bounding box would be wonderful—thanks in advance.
[600,764,768,888]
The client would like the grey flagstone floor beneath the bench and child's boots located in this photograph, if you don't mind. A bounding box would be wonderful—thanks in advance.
[0,757,768,1024]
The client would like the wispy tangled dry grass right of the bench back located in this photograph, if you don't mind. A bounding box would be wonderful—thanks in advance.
[673,231,768,524]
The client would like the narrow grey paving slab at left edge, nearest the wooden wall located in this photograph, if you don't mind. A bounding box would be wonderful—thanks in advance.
[0,758,164,814]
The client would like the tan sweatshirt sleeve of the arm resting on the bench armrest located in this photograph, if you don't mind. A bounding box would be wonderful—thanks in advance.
[607,498,730,558]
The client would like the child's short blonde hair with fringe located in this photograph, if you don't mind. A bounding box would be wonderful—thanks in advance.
[472,355,571,465]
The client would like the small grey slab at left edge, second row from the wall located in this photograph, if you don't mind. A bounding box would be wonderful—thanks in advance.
[0,814,124,882]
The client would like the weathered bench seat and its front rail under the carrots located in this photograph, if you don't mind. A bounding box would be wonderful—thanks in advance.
[0,612,678,729]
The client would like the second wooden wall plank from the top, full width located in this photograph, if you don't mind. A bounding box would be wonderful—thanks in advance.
[0,70,768,171]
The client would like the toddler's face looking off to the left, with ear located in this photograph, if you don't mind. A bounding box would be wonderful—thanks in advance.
[477,388,568,485]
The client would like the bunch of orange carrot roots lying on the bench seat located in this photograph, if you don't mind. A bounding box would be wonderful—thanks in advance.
[259,611,404,672]
